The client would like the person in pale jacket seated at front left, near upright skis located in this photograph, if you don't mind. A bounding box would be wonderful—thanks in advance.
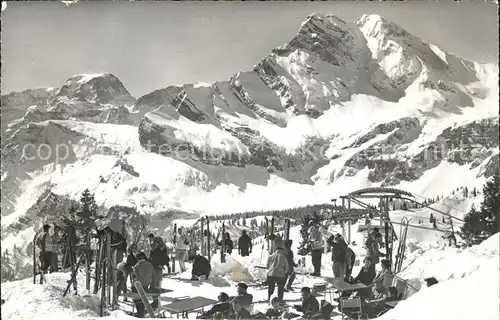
[132,252,160,318]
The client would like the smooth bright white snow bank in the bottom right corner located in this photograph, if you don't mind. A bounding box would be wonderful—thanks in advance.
[379,233,500,320]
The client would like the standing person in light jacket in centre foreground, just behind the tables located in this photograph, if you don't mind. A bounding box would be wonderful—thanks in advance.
[266,240,289,300]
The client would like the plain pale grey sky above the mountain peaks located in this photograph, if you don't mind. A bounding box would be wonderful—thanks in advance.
[1,1,498,97]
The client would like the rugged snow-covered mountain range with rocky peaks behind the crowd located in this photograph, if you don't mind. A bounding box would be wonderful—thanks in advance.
[1,14,499,282]
